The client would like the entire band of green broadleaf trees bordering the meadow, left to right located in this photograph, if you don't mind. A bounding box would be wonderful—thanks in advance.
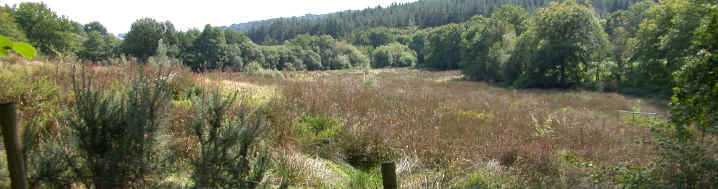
[0,0,708,97]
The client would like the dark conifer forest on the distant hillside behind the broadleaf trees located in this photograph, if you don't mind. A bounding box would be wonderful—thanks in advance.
[248,0,641,44]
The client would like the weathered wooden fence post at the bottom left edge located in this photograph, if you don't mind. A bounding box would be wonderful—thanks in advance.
[0,103,27,189]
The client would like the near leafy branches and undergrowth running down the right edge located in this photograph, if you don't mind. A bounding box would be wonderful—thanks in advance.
[599,5,718,188]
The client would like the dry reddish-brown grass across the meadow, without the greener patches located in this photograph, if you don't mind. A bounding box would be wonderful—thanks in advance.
[0,58,666,188]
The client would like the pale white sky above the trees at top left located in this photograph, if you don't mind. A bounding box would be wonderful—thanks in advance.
[0,0,415,34]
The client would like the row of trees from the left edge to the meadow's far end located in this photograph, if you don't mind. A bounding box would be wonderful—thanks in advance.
[0,2,369,71]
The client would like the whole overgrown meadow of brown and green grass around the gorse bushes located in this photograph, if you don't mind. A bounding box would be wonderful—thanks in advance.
[0,58,667,188]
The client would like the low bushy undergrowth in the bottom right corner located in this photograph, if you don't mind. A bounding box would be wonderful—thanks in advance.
[596,123,718,188]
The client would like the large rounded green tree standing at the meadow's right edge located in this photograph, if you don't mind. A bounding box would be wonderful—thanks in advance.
[509,1,608,88]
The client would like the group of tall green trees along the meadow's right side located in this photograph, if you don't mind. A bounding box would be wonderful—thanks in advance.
[410,0,709,96]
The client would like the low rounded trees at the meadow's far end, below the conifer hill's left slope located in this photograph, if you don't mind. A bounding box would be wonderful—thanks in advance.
[168,25,369,71]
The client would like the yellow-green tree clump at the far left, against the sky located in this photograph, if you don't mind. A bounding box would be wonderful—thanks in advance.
[0,3,115,60]
